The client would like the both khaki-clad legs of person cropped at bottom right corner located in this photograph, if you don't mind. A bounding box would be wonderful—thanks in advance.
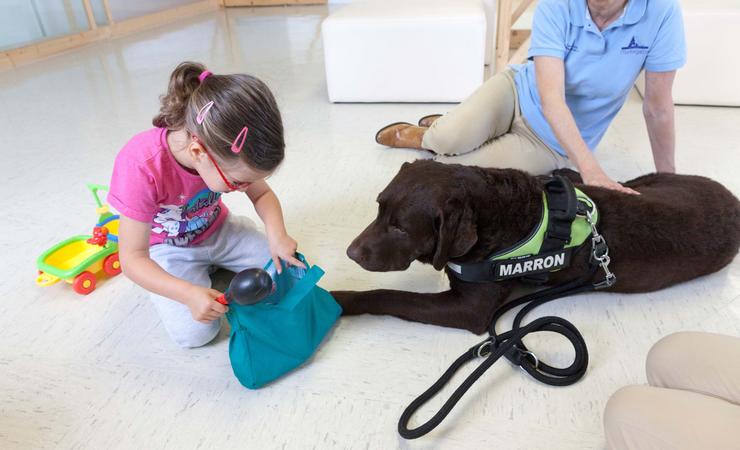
[604,332,740,450]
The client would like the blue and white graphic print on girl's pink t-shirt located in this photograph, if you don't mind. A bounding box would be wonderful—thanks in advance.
[152,188,221,247]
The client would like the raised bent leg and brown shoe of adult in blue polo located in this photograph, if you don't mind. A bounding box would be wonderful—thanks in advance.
[375,70,518,155]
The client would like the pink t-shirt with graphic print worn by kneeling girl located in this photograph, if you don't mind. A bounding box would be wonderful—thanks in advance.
[108,128,229,247]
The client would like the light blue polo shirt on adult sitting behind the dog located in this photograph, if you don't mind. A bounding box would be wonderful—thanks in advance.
[513,0,686,155]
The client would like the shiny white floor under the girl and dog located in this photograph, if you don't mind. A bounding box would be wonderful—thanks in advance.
[0,7,740,449]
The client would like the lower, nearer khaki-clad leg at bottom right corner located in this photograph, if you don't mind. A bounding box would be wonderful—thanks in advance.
[604,386,740,450]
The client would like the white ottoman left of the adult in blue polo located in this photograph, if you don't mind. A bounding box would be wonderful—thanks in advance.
[321,0,486,102]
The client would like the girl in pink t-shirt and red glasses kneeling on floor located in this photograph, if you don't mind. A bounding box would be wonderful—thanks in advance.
[108,62,303,348]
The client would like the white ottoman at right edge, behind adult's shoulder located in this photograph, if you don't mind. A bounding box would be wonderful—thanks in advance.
[637,0,740,106]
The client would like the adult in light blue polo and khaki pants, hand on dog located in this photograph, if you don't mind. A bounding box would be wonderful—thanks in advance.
[376,0,686,193]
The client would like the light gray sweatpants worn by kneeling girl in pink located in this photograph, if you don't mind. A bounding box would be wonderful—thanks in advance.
[149,214,270,348]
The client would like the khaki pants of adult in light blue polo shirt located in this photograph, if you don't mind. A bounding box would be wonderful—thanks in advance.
[422,69,571,175]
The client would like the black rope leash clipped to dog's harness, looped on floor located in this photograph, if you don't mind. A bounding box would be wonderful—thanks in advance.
[398,207,616,439]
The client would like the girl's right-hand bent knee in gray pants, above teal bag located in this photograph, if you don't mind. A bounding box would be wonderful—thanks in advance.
[212,214,271,272]
